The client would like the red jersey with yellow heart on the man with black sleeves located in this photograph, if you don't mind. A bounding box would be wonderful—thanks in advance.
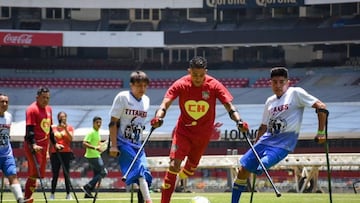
[26,101,52,142]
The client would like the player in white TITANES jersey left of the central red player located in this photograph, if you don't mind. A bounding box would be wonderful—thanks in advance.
[109,71,152,203]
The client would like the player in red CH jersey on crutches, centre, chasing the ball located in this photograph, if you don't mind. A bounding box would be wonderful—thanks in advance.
[151,56,248,203]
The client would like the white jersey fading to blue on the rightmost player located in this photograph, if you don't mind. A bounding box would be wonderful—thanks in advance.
[259,87,318,151]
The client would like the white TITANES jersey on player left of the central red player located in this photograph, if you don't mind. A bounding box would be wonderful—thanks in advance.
[110,91,150,146]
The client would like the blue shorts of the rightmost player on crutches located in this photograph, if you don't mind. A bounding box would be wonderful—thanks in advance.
[240,144,289,175]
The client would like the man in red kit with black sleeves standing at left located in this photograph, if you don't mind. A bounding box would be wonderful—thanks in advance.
[24,87,61,202]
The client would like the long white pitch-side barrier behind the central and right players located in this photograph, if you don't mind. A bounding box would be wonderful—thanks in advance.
[147,153,360,192]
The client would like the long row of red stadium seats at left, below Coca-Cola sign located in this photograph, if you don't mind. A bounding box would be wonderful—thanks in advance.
[0,77,123,89]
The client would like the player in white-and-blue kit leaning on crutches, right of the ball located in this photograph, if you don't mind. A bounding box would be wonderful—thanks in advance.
[231,67,326,203]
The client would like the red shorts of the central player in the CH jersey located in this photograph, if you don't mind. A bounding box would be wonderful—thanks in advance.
[170,131,210,166]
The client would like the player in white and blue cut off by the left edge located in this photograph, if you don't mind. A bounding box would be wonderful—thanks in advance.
[0,93,24,202]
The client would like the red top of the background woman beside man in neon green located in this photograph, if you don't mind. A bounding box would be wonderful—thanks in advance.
[50,125,74,153]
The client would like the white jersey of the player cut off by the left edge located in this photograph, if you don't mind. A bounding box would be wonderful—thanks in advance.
[0,111,12,157]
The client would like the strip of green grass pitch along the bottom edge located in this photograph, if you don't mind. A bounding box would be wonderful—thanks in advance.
[3,192,360,203]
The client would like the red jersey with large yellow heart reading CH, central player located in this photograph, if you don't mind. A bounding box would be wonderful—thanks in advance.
[165,75,233,138]
